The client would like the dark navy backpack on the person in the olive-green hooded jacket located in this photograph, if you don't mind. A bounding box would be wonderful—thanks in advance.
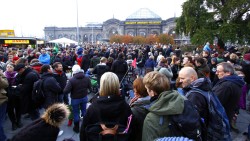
[168,100,202,141]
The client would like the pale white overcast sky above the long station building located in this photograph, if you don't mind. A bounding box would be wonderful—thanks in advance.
[0,0,186,37]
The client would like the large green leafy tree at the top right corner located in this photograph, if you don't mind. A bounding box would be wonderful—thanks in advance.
[176,0,250,45]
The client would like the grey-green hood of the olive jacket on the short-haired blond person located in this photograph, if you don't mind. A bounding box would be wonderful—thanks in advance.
[149,91,186,115]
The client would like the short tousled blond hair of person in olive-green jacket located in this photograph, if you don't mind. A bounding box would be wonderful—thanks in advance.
[143,71,170,95]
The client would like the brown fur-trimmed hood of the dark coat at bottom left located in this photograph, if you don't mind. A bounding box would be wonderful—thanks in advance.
[41,103,69,127]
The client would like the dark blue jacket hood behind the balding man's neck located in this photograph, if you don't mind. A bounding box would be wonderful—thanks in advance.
[188,78,212,91]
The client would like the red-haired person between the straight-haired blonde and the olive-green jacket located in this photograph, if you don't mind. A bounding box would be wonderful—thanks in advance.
[129,77,150,141]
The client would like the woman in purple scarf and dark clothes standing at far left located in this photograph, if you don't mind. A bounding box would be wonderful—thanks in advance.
[4,63,23,131]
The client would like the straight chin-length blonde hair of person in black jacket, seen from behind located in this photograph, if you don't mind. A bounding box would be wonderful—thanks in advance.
[100,72,120,96]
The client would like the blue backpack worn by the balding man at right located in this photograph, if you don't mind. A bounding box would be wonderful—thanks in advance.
[186,88,231,141]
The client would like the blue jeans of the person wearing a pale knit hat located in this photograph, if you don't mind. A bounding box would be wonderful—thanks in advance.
[71,96,88,122]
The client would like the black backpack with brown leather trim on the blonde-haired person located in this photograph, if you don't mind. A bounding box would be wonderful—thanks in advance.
[85,107,132,141]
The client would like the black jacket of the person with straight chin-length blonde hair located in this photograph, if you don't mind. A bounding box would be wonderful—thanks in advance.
[80,95,132,141]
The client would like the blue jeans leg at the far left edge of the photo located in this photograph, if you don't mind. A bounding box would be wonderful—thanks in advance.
[0,102,7,141]
